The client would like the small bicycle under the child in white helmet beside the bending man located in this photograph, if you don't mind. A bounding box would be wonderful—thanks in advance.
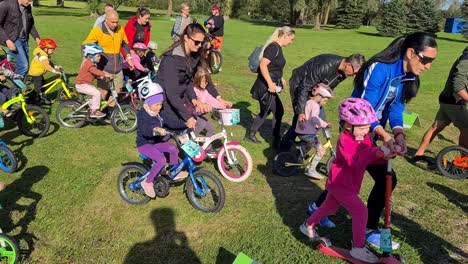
[274,128,336,177]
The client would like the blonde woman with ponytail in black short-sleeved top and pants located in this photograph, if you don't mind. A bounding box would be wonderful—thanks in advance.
[245,26,295,148]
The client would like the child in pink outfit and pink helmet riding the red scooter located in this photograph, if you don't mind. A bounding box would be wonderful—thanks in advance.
[300,98,394,263]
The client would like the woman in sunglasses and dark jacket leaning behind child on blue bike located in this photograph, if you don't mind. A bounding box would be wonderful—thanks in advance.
[156,23,211,128]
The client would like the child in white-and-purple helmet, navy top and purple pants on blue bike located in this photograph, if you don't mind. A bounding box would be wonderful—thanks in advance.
[136,83,185,198]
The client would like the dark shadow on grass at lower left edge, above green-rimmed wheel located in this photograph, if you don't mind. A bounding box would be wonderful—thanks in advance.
[0,166,49,258]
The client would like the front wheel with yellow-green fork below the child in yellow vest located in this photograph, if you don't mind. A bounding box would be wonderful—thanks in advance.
[17,105,50,138]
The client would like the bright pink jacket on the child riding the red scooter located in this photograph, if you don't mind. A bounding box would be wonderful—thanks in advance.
[326,131,385,195]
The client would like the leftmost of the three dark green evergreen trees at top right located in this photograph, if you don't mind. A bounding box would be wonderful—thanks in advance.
[336,0,364,29]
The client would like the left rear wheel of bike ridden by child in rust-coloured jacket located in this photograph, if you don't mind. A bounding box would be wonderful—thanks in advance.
[55,100,88,128]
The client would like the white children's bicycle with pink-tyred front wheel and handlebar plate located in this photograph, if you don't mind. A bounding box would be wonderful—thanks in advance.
[193,109,253,182]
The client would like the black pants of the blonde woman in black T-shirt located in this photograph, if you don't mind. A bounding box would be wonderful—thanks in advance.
[250,92,284,140]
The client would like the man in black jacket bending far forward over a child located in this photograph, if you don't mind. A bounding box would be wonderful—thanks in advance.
[279,54,365,152]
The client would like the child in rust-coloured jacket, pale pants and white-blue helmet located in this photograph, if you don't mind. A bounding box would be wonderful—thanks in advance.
[76,43,112,118]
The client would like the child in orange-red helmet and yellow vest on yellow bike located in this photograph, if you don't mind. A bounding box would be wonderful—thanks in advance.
[28,38,62,105]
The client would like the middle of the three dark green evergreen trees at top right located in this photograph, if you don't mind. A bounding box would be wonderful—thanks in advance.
[377,0,406,37]
